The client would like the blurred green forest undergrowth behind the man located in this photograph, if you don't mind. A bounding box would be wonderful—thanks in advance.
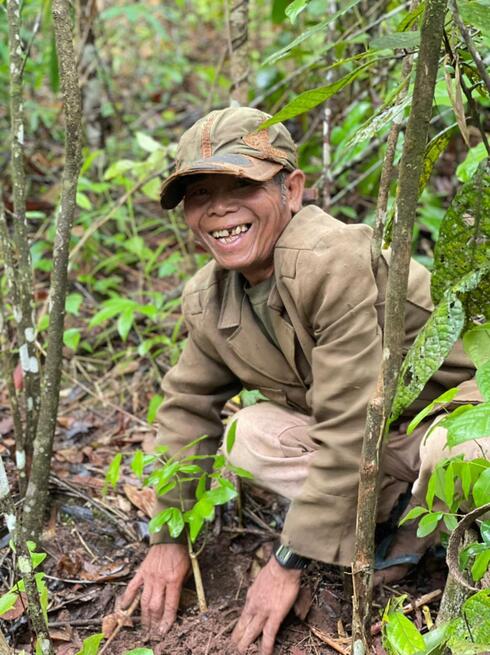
[0,0,490,652]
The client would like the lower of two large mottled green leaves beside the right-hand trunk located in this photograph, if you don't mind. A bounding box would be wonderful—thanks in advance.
[391,295,465,420]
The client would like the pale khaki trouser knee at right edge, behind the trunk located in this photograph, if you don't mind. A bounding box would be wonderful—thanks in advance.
[412,416,490,503]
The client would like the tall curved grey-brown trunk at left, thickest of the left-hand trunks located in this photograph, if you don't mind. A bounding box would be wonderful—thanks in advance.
[23,0,81,539]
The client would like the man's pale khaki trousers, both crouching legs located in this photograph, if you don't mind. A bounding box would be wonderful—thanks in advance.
[225,402,490,529]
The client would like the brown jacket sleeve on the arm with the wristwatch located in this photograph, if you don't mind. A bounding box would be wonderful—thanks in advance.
[282,226,382,566]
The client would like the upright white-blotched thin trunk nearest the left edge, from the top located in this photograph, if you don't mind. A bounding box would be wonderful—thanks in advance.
[7,0,39,490]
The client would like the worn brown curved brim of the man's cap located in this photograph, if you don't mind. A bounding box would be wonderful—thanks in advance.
[160,154,284,209]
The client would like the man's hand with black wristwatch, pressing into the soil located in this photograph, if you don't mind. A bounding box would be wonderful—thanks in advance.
[231,557,301,655]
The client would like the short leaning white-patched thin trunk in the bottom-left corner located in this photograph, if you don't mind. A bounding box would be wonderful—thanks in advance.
[0,456,54,655]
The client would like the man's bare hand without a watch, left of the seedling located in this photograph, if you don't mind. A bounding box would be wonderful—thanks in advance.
[121,544,191,635]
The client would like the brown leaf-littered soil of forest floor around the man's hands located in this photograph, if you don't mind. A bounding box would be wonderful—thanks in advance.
[0,371,445,655]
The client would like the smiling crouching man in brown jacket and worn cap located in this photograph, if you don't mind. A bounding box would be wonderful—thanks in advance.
[123,108,480,655]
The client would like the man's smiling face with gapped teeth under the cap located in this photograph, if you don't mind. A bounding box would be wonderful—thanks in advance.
[184,171,302,285]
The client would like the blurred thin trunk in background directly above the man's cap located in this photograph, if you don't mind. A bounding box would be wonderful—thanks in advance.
[225,0,250,106]
